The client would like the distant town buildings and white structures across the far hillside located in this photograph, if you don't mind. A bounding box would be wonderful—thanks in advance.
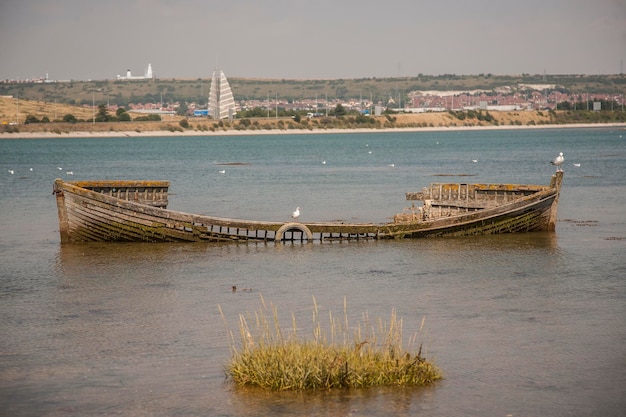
[0,64,626,118]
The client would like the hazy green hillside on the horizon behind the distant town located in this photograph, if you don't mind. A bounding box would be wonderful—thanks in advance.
[0,74,626,106]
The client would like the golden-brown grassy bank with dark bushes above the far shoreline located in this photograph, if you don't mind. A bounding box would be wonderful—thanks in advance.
[0,97,626,138]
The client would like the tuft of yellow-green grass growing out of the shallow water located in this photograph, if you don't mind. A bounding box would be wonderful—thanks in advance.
[220,297,442,390]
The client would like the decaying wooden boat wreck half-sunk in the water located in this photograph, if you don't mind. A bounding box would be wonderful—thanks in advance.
[54,172,563,243]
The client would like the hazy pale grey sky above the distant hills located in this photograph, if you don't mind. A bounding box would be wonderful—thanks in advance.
[0,0,626,80]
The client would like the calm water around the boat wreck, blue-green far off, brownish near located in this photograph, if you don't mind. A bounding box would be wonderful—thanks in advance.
[0,129,626,417]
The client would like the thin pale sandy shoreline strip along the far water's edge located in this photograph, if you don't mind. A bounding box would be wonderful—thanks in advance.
[0,123,626,140]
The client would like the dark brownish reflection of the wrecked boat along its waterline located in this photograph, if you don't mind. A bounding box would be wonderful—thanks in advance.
[56,232,558,279]
